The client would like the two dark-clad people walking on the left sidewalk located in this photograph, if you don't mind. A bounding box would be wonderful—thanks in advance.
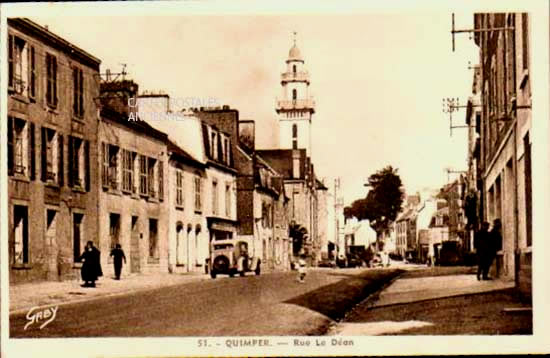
[80,241,126,287]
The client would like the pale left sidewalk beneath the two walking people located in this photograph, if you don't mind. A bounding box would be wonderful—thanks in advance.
[9,272,210,314]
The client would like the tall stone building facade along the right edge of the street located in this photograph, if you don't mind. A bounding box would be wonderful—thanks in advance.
[474,13,532,295]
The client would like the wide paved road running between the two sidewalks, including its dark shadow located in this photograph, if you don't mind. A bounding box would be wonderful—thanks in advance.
[10,269,396,337]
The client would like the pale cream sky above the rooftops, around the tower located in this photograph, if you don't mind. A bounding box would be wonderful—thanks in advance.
[22,11,478,204]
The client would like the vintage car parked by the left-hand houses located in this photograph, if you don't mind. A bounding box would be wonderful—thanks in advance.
[210,240,261,278]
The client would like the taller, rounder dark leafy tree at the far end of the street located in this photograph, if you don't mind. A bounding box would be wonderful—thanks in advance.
[365,166,403,233]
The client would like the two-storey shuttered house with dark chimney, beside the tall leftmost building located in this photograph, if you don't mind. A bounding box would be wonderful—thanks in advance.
[97,80,170,277]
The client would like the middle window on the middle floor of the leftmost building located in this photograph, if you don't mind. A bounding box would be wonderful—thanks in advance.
[42,127,59,184]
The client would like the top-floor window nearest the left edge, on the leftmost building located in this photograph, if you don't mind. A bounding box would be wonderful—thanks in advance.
[8,35,28,94]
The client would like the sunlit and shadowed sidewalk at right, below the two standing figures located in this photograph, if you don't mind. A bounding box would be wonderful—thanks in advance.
[329,274,532,336]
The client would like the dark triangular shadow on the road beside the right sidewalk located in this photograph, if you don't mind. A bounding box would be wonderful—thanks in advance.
[285,269,403,320]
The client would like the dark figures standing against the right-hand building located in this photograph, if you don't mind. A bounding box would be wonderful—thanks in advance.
[474,219,502,280]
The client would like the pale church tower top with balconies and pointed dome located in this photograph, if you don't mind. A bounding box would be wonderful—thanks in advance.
[275,32,315,157]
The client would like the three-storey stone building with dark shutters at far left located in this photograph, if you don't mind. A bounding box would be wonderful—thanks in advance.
[7,18,100,284]
